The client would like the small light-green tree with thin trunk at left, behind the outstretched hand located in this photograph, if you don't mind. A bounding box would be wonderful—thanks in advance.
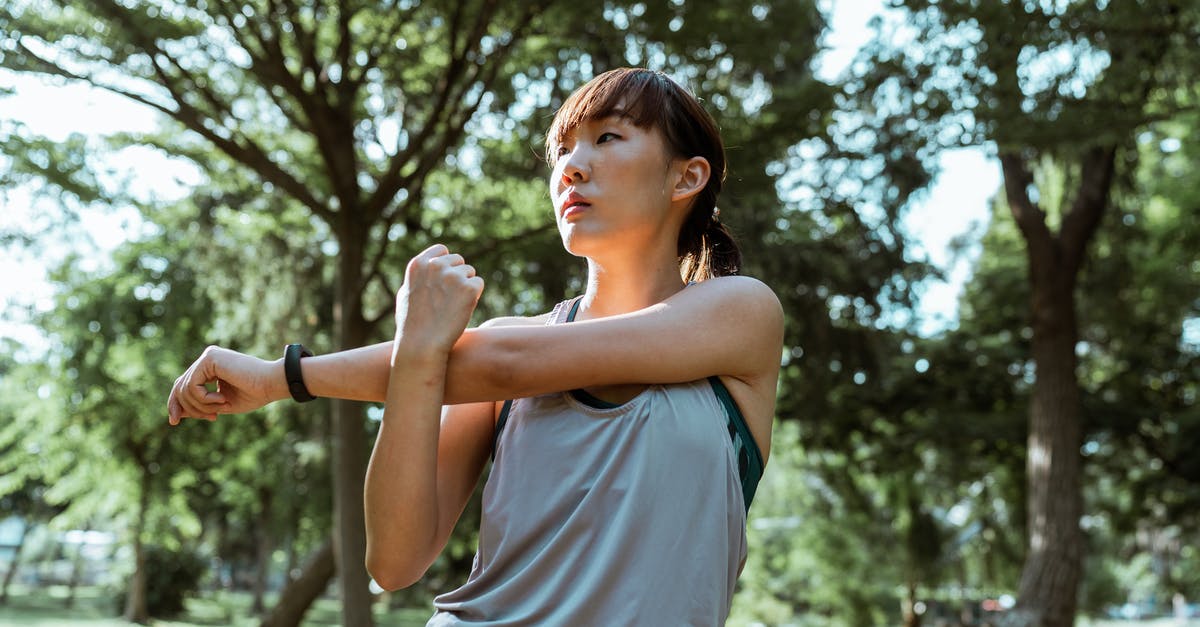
[20,235,218,622]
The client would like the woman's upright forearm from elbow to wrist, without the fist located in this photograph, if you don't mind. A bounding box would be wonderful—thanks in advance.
[359,344,446,589]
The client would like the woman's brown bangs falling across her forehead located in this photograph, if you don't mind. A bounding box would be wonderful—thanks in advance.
[546,67,672,166]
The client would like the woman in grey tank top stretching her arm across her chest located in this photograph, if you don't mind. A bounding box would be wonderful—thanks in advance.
[168,68,782,626]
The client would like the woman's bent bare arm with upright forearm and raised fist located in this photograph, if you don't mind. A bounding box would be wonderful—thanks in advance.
[364,246,492,590]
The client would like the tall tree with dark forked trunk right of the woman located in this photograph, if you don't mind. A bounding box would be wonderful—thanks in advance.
[844,1,1198,626]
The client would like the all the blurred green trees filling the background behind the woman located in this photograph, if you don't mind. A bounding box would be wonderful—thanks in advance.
[0,0,1200,625]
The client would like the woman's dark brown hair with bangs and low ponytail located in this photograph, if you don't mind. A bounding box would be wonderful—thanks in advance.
[546,67,742,281]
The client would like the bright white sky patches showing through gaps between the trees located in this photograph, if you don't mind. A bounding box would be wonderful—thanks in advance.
[0,0,1001,353]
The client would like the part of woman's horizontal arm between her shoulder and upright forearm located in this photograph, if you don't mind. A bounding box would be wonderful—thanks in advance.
[446,276,784,402]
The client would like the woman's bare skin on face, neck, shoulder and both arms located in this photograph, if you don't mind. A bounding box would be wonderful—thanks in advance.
[168,114,784,589]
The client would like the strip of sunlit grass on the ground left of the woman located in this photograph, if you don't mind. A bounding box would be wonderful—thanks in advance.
[0,585,433,627]
